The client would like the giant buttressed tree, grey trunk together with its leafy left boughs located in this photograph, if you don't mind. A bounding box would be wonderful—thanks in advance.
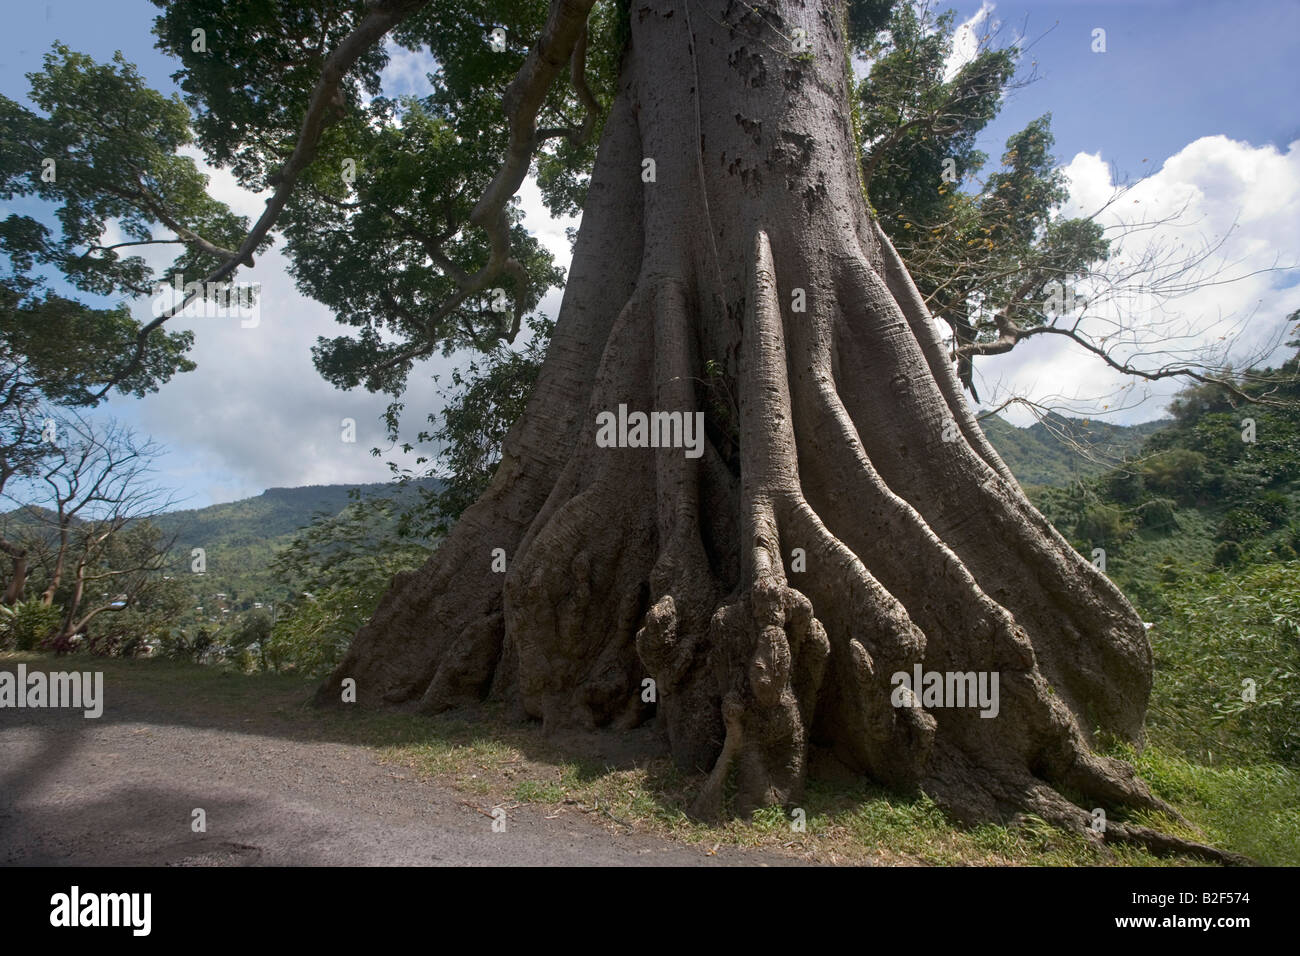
[17,0,1227,858]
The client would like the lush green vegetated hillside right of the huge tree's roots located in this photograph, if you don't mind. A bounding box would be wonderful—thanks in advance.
[1031,343,1300,769]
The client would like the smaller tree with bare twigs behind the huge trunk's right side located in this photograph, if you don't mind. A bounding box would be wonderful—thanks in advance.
[857,3,1286,414]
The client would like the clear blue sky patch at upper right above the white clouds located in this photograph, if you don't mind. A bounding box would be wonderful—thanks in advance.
[950,0,1300,176]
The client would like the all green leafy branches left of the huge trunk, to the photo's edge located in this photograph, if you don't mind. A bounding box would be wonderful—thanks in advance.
[0,0,619,399]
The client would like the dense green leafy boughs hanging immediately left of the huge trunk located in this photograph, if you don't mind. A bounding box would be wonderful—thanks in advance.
[148,0,618,394]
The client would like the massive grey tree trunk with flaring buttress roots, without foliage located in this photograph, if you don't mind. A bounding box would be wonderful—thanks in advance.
[319,0,1232,852]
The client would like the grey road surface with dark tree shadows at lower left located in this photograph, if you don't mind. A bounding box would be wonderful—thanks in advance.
[0,665,797,866]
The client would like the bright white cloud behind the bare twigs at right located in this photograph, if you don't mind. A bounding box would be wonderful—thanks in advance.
[975,135,1300,424]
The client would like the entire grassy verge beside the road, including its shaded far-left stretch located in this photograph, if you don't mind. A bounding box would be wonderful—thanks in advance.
[0,653,1300,866]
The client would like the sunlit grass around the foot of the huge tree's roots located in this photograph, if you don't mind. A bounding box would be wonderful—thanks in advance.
[382,718,1300,866]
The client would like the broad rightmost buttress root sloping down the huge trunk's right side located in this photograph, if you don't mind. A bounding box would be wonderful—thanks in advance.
[836,256,1151,740]
